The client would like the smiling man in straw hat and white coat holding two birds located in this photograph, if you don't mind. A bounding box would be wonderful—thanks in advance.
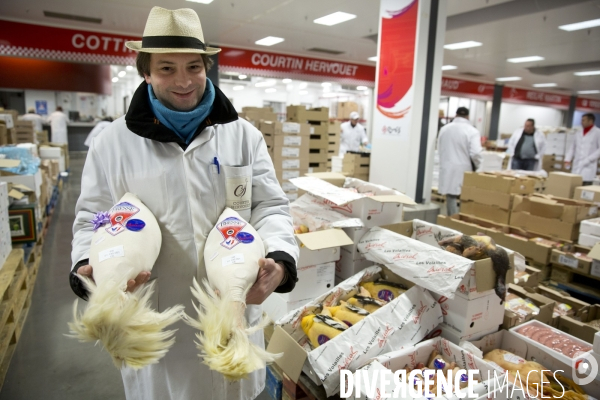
[69,7,299,400]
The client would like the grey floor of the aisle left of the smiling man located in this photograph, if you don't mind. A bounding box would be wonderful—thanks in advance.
[0,154,125,400]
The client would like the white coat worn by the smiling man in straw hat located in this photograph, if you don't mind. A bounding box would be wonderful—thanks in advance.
[72,117,299,400]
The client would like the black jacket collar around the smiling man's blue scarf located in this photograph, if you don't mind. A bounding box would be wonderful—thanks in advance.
[125,81,238,150]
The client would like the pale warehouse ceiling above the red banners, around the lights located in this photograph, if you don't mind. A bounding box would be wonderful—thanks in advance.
[0,0,600,98]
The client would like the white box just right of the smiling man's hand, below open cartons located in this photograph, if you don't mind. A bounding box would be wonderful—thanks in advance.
[280,262,335,302]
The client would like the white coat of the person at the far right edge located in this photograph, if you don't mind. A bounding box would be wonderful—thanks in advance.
[565,126,600,182]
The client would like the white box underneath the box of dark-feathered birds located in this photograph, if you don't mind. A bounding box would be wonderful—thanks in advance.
[431,292,504,337]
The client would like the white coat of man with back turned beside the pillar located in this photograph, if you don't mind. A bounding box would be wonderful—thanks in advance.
[438,117,481,196]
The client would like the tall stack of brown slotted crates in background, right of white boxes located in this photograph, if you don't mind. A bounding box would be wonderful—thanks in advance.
[287,106,329,172]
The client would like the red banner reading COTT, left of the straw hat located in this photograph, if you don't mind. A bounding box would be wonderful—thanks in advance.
[0,21,140,65]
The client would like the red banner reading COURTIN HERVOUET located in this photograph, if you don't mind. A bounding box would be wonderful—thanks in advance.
[219,47,375,86]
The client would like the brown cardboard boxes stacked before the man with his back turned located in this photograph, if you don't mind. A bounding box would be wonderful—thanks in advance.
[460,172,535,225]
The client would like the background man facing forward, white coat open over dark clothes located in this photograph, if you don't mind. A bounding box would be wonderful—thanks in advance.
[506,118,546,171]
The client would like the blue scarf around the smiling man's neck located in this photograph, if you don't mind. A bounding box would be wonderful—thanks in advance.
[148,78,215,144]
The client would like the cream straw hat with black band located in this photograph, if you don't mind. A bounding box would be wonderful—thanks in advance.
[125,7,221,55]
